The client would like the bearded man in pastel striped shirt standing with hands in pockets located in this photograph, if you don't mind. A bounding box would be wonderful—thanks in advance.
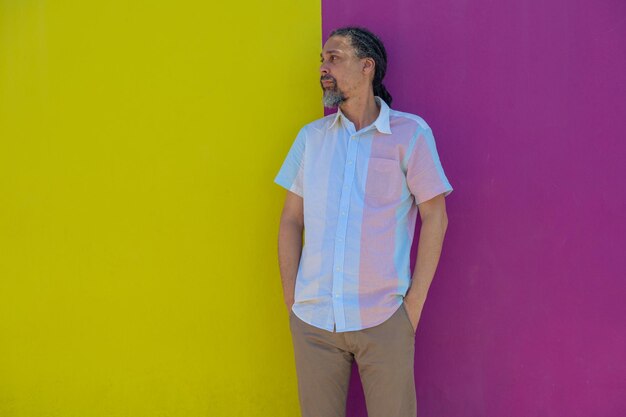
[274,27,452,417]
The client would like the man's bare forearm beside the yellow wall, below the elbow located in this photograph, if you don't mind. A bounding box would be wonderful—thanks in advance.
[278,221,304,308]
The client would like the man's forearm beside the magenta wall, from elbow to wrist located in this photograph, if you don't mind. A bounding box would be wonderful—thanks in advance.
[406,214,448,305]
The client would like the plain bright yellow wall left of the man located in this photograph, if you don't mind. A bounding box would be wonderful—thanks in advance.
[0,0,322,417]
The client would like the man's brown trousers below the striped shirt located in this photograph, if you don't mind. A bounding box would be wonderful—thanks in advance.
[289,303,417,417]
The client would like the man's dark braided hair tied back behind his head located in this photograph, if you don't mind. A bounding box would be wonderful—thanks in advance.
[330,26,392,106]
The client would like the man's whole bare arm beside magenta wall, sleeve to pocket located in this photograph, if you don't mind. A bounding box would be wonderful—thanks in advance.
[404,194,448,329]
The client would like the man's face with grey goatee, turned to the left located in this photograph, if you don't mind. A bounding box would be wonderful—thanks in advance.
[320,36,369,108]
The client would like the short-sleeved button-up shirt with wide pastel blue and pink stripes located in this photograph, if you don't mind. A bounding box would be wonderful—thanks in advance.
[274,96,452,332]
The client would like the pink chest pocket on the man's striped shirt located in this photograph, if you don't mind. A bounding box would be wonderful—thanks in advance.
[365,158,405,204]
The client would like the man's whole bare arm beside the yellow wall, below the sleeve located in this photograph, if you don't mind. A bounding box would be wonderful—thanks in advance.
[278,191,304,311]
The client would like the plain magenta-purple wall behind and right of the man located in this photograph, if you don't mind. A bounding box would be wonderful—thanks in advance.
[323,0,626,417]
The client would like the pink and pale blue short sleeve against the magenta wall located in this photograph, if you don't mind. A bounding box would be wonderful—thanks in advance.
[406,127,452,204]
